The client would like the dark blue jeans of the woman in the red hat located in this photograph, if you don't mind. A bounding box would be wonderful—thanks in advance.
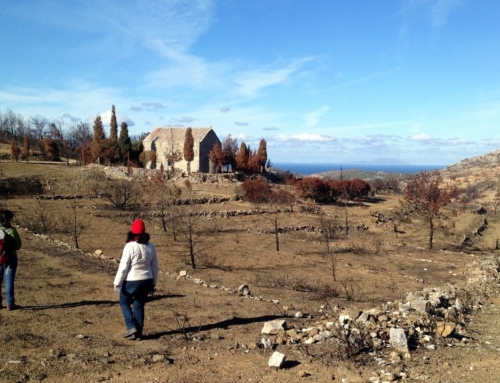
[120,279,153,335]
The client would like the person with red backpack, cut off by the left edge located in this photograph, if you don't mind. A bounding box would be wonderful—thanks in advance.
[0,210,21,310]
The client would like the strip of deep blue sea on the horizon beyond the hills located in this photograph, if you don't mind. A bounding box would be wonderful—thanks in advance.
[273,162,448,175]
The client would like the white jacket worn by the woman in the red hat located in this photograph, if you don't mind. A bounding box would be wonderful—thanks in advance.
[114,241,158,286]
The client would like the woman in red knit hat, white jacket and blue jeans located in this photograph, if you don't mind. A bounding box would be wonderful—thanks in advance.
[114,219,158,340]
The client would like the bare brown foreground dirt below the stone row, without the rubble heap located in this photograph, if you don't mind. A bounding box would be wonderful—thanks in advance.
[0,232,500,383]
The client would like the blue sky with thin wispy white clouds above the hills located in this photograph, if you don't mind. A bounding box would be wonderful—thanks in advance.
[0,0,500,165]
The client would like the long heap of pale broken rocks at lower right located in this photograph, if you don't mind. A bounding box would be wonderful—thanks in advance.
[261,258,500,368]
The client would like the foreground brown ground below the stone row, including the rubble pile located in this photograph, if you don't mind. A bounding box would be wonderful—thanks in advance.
[0,225,500,383]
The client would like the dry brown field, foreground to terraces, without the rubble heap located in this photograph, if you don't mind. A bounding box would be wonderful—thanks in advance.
[0,157,500,383]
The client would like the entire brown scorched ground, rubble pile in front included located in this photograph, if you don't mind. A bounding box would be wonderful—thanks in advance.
[0,157,500,383]
